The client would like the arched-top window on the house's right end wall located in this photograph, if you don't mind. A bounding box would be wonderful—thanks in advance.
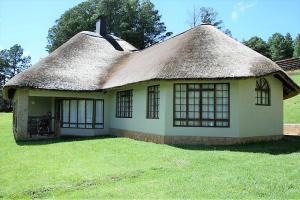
[255,78,270,106]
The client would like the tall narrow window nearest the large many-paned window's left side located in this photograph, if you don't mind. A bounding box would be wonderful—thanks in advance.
[147,85,159,119]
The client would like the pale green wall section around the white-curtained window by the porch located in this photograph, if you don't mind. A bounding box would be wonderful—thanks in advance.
[29,89,110,136]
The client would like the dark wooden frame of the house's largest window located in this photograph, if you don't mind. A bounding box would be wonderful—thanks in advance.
[173,83,230,128]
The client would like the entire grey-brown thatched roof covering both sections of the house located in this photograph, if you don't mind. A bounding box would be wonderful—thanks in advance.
[5,25,299,97]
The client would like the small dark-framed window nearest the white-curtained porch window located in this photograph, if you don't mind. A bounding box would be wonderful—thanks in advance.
[116,90,132,118]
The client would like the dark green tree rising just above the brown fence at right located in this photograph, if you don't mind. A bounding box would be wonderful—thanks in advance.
[268,33,293,61]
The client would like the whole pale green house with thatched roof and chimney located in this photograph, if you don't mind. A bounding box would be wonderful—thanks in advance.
[4,20,299,144]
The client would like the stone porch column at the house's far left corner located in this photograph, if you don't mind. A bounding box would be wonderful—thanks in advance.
[15,89,29,140]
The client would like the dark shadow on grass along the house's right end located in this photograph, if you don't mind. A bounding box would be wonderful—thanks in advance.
[174,136,300,155]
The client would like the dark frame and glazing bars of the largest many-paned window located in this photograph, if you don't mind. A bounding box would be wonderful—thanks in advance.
[173,83,230,128]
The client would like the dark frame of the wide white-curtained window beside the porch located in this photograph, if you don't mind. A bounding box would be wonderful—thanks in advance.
[59,98,104,129]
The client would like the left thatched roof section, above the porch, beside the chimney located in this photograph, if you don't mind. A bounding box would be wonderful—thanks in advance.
[5,32,136,91]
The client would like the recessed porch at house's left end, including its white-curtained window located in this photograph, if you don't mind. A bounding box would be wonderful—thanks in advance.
[13,90,108,140]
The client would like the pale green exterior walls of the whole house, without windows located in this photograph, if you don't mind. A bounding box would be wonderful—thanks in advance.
[15,76,283,140]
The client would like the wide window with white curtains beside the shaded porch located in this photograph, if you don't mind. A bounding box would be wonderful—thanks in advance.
[61,99,104,129]
